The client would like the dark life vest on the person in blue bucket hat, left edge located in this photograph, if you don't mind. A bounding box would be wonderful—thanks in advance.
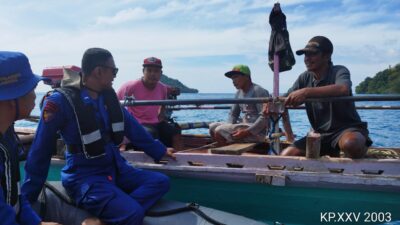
[0,128,20,214]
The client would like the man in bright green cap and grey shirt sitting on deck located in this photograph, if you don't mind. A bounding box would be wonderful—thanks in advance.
[210,65,269,145]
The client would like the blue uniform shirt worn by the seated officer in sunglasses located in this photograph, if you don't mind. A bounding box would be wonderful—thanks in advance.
[22,89,166,202]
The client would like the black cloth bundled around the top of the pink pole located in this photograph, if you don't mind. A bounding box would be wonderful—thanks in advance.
[268,3,296,72]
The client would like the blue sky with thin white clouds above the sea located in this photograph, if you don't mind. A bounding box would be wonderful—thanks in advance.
[0,0,400,93]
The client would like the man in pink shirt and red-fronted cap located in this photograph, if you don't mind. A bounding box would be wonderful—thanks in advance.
[118,57,182,150]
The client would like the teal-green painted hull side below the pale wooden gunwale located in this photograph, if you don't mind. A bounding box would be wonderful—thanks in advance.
[166,177,400,224]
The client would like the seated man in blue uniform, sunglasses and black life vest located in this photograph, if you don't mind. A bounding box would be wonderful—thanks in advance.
[22,48,174,224]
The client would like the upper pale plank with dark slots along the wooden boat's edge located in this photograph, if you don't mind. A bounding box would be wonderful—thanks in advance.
[122,151,400,178]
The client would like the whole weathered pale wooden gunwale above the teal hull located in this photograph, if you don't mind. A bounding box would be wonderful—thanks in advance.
[123,152,400,193]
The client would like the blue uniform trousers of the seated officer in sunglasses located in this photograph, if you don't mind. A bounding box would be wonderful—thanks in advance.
[71,169,169,225]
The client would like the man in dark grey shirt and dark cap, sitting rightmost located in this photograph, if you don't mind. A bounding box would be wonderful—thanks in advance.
[282,36,372,158]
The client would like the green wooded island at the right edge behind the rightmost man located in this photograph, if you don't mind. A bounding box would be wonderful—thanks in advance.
[356,63,400,94]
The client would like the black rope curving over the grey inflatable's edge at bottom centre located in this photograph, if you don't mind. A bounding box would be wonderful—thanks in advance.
[146,202,225,225]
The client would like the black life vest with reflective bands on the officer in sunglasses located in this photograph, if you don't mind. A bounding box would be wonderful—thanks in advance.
[56,86,124,159]
